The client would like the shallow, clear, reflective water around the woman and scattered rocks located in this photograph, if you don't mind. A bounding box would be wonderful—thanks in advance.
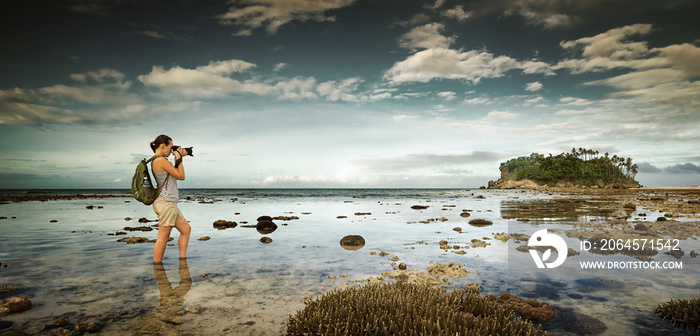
[0,190,700,335]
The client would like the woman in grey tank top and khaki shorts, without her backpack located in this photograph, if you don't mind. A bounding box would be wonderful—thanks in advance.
[151,134,191,263]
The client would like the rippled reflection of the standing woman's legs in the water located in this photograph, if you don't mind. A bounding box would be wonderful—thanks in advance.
[137,259,192,335]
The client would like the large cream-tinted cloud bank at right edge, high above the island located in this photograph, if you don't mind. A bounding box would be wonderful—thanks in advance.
[553,24,700,115]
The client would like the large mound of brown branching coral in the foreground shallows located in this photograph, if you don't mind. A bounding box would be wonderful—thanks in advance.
[287,283,546,336]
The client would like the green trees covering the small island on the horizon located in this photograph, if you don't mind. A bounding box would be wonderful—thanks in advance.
[500,148,640,187]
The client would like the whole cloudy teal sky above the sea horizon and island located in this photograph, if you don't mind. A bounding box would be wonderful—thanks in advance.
[0,0,700,189]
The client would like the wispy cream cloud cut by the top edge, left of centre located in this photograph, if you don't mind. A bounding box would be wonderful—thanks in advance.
[218,0,355,35]
